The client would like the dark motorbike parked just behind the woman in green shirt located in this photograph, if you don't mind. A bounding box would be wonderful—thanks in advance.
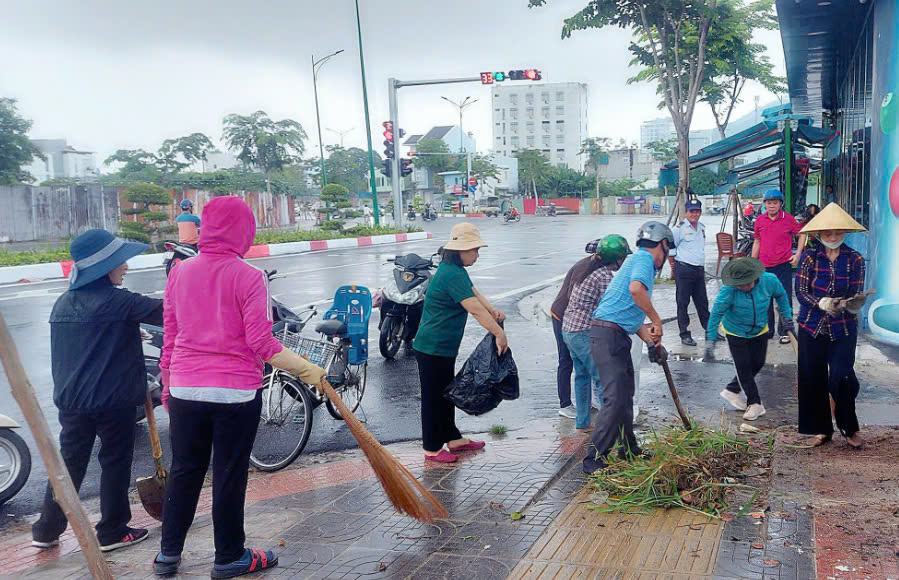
[378,254,437,360]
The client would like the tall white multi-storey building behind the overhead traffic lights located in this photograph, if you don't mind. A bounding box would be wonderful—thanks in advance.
[490,83,588,171]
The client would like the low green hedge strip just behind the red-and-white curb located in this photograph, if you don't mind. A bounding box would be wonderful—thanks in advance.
[0,225,424,266]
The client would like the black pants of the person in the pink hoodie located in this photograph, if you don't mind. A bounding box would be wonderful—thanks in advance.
[161,390,262,564]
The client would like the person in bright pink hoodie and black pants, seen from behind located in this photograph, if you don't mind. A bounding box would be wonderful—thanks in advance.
[153,197,325,578]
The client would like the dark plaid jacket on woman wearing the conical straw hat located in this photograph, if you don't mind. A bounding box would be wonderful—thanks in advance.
[796,244,865,340]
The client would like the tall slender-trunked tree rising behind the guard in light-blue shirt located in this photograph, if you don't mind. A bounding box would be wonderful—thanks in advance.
[528,0,717,213]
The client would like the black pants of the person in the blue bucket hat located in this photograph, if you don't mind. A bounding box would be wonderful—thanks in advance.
[32,408,135,544]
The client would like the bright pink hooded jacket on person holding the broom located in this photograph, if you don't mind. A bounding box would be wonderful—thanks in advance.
[159,197,282,390]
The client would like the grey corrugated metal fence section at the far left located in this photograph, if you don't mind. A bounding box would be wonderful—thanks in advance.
[0,184,121,242]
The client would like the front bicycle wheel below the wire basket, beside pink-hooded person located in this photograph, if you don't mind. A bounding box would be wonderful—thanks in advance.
[250,373,312,471]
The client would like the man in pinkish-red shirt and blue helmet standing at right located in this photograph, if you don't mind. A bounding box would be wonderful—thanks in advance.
[752,189,805,344]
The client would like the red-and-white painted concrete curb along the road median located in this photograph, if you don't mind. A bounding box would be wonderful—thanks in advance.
[0,232,431,284]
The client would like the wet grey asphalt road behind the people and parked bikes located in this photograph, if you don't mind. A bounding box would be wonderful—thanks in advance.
[0,216,660,529]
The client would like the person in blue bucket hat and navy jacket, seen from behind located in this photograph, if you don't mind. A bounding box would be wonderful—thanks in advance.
[31,229,162,552]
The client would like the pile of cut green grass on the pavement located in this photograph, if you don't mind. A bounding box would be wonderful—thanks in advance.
[590,425,755,518]
